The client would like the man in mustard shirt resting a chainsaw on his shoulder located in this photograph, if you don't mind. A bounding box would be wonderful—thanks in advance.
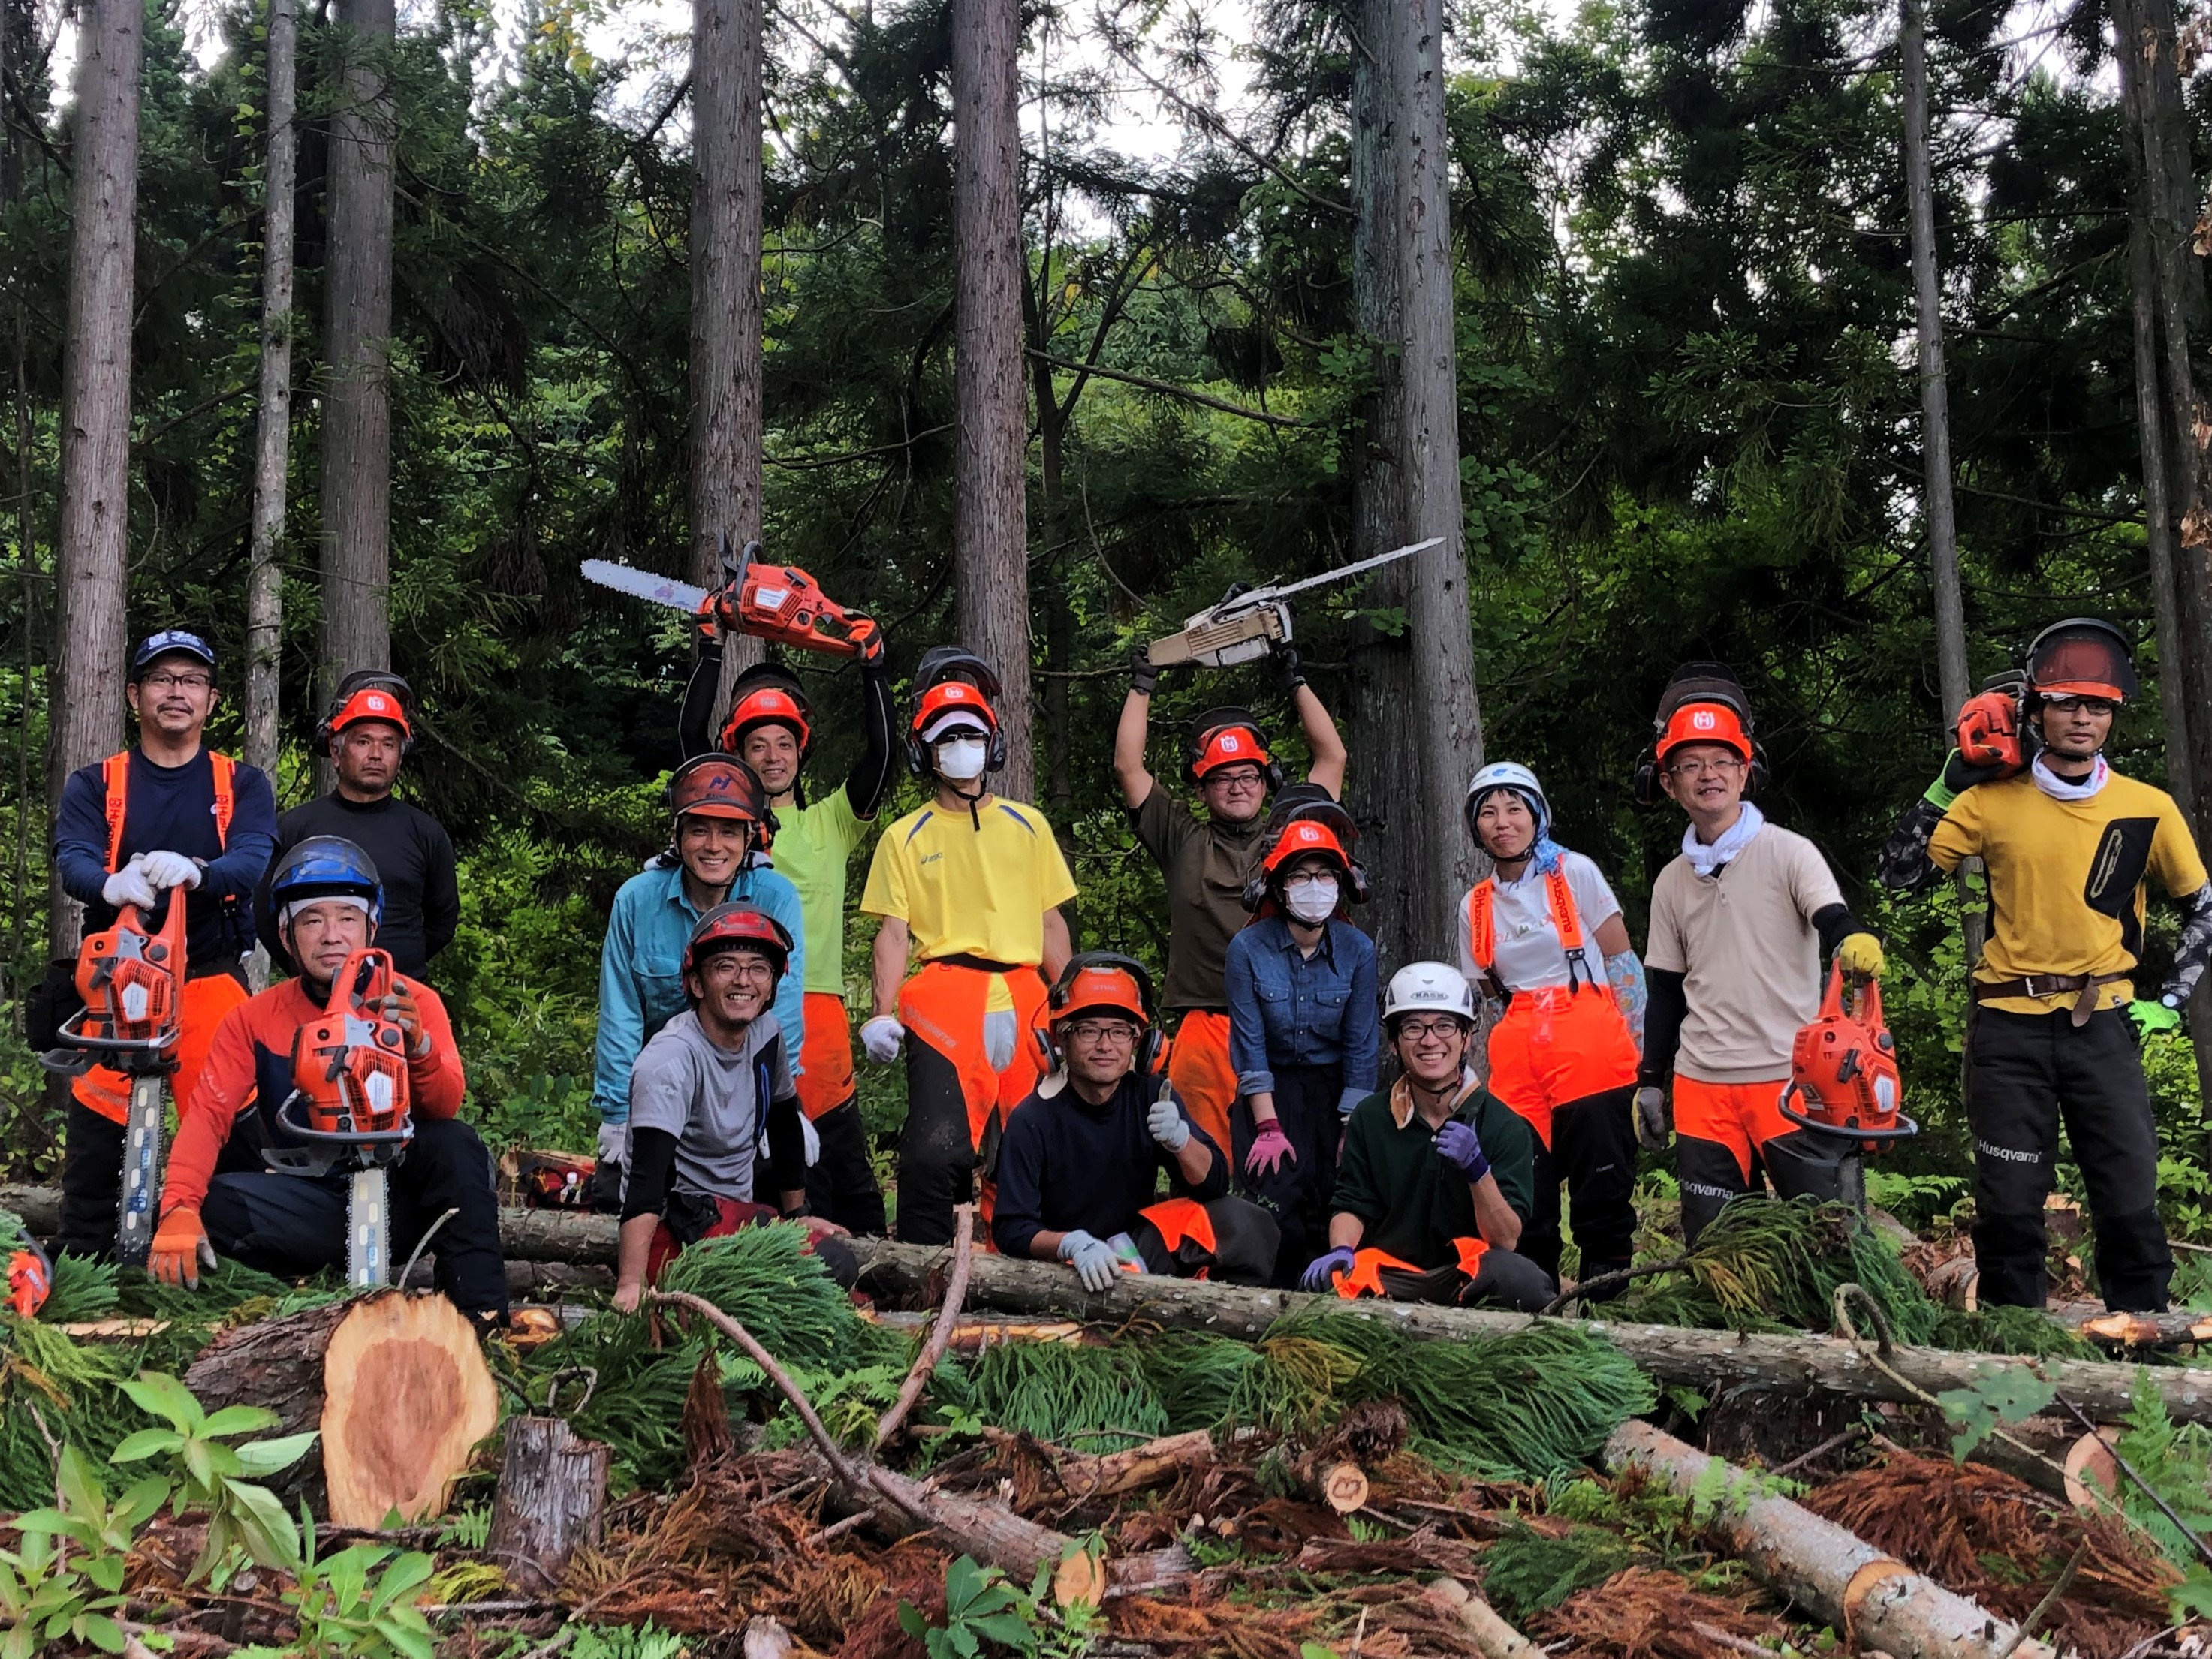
[1882,617,2212,1311]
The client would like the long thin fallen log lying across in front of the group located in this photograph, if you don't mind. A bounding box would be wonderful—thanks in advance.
[849,1239,2212,1423]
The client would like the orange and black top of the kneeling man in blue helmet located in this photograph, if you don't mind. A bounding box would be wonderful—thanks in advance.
[161,980,465,1215]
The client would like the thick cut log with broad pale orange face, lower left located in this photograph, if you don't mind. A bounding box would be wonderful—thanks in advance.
[184,1290,500,1528]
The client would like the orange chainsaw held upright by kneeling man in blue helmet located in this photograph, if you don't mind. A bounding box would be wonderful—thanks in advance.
[264,949,414,1290]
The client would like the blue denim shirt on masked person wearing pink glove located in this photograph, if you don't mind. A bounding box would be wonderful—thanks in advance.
[1225,916,1382,1101]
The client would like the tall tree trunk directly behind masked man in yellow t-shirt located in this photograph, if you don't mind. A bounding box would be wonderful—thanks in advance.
[954,0,1035,801]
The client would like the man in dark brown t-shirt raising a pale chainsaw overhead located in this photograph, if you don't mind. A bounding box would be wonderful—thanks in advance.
[1113,642,1345,1146]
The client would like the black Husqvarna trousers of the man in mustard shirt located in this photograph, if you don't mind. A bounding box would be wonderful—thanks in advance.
[1966,1007,2174,1311]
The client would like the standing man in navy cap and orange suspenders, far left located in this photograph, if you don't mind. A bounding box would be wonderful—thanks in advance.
[53,628,276,1257]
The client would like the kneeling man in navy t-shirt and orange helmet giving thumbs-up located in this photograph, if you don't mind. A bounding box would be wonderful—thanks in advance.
[991,951,1281,1292]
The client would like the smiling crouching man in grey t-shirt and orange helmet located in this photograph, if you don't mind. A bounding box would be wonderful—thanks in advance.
[615,905,860,1314]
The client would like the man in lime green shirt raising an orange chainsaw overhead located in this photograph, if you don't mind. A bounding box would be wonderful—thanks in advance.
[679,604,896,1236]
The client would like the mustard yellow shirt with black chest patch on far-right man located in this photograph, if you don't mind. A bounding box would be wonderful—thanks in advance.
[1929,772,2205,1013]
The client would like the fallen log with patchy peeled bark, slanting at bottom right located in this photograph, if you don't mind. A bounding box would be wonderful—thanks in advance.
[1606,1420,2057,1659]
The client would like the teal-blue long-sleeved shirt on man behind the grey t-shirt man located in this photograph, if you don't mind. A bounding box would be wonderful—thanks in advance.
[591,865,807,1124]
